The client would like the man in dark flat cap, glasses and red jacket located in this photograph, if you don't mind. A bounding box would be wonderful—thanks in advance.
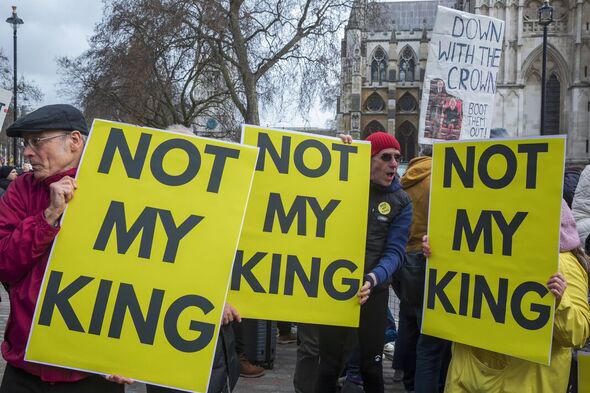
[0,105,131,393]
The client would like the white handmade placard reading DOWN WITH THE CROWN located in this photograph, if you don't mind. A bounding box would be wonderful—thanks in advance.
[418,6,504,143]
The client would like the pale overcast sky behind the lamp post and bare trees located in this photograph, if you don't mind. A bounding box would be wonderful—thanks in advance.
[0,0,335,127]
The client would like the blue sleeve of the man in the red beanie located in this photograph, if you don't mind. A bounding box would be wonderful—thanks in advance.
[370,202,412,285]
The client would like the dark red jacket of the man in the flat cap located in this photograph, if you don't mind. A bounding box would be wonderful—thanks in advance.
[0,169,87,382]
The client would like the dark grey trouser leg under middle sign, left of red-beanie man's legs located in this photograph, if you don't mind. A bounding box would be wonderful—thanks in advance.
[293,323,320,393]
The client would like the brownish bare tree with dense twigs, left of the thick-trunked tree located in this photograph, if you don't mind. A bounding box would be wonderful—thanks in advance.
[58,0,237,134]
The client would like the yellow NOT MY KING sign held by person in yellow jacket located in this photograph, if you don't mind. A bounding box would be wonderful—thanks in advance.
[422,136,565,364]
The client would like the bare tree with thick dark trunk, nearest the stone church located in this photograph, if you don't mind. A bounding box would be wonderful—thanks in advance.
[185,0,352,124]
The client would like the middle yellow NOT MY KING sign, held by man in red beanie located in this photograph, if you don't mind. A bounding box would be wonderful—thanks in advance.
[228,125,371,326]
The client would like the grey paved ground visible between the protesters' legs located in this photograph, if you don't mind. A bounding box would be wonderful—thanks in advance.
[0,286,404,393]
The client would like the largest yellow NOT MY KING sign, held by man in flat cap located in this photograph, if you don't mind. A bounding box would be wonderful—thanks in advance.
[25,120,258,392]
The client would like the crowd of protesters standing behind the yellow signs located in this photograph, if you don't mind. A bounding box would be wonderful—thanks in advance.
[0,105,590,393]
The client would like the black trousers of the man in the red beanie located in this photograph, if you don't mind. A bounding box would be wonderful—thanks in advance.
[315,288,389,393]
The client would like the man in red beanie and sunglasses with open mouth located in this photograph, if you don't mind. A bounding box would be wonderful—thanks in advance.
[316,132,412,393]
